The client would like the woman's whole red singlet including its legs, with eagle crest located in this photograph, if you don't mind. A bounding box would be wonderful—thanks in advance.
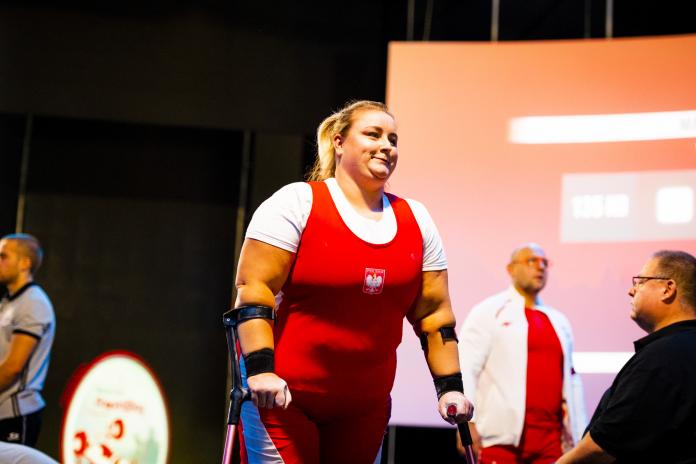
[239,182,423,463]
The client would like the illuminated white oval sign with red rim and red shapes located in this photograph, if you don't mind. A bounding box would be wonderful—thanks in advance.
[60,351,169,464]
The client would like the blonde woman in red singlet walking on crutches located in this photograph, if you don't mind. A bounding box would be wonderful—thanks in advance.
[235,101,473,464]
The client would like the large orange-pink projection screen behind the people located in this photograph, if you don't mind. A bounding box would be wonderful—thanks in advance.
[387,36,696,426]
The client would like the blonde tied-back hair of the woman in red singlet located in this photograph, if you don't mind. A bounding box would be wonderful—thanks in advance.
[308,100,394,181]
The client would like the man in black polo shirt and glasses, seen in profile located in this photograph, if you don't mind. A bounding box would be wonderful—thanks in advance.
[558,251,696,464]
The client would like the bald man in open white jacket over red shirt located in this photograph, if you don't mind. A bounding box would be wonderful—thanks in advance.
[459,244,587,464]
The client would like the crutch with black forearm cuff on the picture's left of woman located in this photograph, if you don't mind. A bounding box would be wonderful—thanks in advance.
[222,309,251,464]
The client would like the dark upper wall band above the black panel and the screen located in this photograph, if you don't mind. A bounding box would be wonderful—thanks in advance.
[0,0,696,134]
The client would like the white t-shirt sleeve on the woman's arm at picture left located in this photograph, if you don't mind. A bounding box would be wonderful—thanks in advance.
[246,182,312,253]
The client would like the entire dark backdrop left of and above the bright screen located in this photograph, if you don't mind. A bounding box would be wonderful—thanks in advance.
[0,0,696,463]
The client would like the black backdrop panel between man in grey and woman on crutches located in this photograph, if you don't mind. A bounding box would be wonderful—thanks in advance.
[24,118,242,463]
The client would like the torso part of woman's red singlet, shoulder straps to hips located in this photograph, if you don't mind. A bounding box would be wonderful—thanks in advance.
[274,182,423,402]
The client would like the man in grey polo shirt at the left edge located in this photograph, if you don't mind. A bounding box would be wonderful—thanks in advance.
[0,234,56,446]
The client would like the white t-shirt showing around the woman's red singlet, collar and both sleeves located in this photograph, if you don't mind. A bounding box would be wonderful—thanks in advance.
[246,178,447,271]
